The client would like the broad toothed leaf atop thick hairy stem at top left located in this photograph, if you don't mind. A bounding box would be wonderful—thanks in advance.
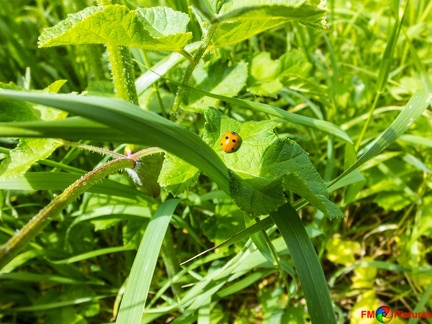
[39,5,192,51]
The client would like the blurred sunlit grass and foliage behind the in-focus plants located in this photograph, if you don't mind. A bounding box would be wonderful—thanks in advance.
[0,0,432,323]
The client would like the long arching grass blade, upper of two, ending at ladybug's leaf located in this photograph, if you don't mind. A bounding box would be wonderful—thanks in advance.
[0,90,229,193]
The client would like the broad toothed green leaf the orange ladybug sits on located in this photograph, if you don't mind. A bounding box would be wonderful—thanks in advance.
[203,109,343,218]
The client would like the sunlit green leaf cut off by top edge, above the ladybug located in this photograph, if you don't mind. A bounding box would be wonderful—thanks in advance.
[211,0,326,48]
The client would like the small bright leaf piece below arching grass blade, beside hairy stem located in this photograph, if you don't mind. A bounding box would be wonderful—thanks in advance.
[158,153,200,196]
